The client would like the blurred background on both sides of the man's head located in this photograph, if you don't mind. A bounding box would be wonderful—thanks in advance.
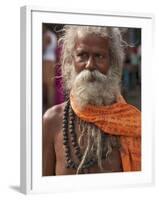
[42,23,141,113]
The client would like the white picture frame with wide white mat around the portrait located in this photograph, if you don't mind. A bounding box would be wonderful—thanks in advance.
[21,7,154,193]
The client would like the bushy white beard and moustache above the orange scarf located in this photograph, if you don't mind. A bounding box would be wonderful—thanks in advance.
[72,70,119,107]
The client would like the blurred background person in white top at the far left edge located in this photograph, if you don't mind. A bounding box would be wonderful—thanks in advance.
[43,27,57,112]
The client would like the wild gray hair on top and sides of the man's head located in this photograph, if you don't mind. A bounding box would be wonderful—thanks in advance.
[60,25,125,92]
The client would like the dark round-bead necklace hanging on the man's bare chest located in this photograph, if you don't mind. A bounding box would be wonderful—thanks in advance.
[63,100,97,169]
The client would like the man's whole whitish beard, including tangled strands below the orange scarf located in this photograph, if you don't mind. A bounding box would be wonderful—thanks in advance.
[71,68,120,174]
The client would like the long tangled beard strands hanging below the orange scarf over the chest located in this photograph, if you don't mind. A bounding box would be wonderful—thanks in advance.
[76,121,120,174]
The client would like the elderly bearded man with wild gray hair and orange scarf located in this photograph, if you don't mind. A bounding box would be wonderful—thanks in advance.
[43,26,141,176]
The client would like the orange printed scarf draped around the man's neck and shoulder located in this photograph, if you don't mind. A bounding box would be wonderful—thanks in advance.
[70,94,141,171]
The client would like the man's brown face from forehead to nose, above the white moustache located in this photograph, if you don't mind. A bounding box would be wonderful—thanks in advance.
[73,35,109,75]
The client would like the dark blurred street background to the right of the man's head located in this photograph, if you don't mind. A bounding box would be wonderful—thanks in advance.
[122,28,141,110]
